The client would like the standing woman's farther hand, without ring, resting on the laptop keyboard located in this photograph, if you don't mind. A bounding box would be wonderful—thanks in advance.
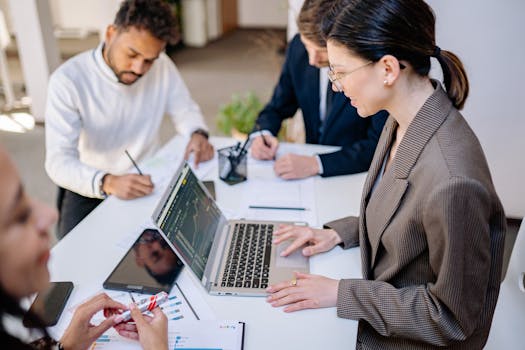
[273,225,342,256]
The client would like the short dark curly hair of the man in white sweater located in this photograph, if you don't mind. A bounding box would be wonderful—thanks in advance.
[113,0,179,44]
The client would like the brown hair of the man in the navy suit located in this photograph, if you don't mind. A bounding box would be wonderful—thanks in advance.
[297,0,335,47]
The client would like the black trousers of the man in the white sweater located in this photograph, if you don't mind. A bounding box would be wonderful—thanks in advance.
[57,187,103,240]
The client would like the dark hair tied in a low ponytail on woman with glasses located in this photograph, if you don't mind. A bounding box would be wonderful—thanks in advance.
[323,0,469,109]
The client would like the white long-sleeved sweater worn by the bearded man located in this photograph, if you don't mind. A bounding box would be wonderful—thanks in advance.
[45,44,206,198]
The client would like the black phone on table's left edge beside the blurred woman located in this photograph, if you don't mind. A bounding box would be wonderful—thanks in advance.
[23,282,73,328]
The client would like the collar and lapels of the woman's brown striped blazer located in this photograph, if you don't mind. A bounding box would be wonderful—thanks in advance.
[360,81,452,269]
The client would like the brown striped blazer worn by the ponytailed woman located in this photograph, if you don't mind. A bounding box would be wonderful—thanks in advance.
[325,81,506,350]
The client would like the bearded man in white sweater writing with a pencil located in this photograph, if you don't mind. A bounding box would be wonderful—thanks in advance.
[45,0,213,238]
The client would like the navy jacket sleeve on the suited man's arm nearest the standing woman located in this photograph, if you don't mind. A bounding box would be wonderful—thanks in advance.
[319,111,388,177]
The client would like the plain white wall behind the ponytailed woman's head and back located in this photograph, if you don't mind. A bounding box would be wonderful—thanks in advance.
[428,0,525,217]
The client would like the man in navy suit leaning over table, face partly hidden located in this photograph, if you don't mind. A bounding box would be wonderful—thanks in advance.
[252,0,387,179]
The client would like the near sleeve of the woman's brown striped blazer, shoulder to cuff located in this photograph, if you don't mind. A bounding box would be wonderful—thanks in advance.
[337,178,492,346]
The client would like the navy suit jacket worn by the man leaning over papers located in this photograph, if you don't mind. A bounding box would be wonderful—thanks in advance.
[257,35,387,176]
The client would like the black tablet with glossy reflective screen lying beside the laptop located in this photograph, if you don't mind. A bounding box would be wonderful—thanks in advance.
[103,228,184,294]
